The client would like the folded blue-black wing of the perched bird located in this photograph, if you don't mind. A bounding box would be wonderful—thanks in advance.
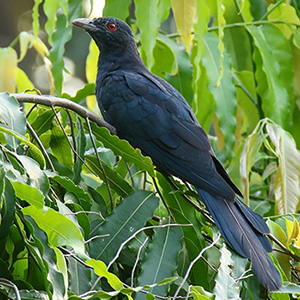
[99,71,240,201]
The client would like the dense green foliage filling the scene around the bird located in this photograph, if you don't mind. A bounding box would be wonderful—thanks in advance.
[0,0,300,300]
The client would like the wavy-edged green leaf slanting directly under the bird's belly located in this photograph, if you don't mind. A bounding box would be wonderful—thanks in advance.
[91,123,154,176]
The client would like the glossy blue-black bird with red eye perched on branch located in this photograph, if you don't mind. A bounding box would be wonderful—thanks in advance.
[72,18,281,291]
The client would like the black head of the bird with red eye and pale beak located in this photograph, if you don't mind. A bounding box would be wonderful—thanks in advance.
[72,17,135,52]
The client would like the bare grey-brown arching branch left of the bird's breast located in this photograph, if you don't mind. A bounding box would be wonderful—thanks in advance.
[11,94,117,134]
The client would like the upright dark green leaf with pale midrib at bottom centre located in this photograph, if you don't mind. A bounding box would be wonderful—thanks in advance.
[135,221,182,299]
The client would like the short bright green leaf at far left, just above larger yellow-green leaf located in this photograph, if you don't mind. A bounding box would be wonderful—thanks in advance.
[11,181,45,208]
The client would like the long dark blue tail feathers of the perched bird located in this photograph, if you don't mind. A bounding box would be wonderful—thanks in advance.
[196,188,281,291]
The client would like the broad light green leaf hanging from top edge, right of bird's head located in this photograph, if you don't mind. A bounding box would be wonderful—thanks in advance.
[134,0,159,70]
